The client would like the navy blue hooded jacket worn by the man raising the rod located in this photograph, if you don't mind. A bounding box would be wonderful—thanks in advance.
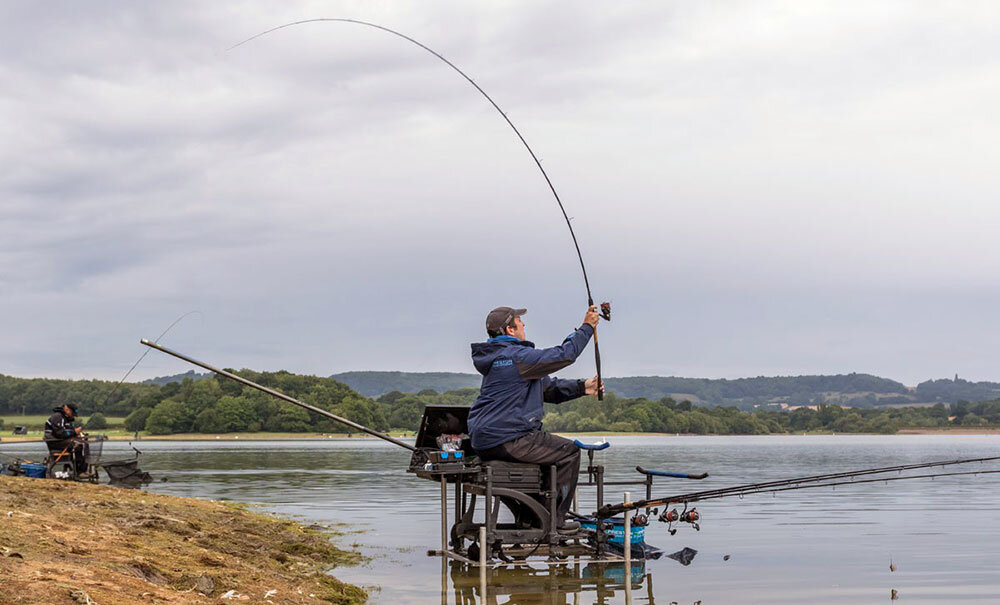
[469,324,594,450]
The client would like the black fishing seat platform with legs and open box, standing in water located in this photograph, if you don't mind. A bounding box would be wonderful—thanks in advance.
[407,405,688,567]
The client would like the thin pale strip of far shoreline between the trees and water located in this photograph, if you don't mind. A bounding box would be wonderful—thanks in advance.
[0,426,1000,446]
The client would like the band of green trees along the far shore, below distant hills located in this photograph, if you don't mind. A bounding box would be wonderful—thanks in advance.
[0,370,1000,435]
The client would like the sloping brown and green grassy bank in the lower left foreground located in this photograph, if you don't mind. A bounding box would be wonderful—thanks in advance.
[0,476,366,605]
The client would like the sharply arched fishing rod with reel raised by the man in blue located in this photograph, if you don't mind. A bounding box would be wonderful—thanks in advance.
[227,17,611,401]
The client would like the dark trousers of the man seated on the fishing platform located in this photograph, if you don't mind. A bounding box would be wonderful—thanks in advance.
[479,431,580,519]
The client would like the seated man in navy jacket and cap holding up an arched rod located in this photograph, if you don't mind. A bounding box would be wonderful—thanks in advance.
[469,306,603,530]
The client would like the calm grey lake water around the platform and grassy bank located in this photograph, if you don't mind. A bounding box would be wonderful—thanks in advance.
[0,436,1000,605]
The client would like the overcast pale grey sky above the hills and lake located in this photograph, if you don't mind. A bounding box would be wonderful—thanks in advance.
[0,0,1000,384]
